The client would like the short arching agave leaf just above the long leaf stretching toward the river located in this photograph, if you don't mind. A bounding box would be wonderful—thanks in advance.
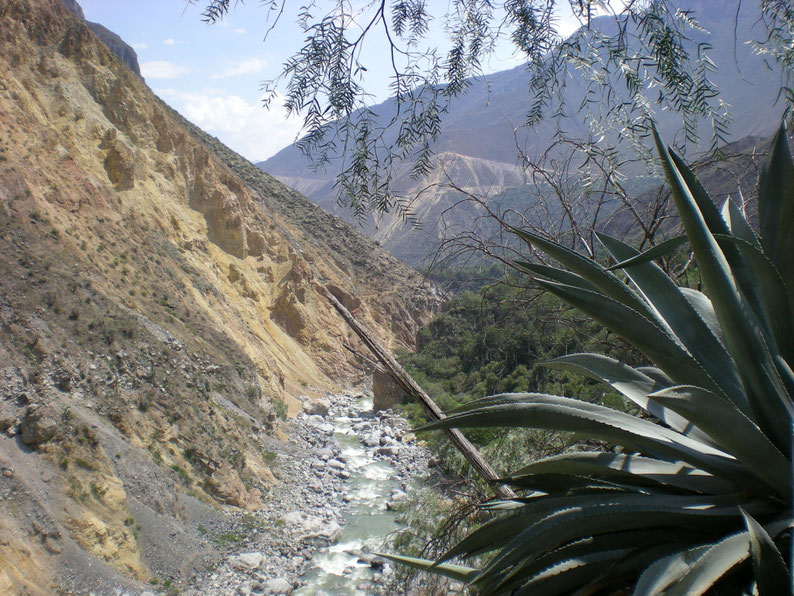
[541,354,711,443]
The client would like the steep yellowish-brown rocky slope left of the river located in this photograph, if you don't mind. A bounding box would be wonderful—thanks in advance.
[0,0,440,594]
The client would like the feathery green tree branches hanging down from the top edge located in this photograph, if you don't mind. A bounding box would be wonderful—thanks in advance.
[193,0,794,221]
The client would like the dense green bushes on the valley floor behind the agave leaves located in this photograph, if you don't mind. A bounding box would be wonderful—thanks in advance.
[400,279,639,482]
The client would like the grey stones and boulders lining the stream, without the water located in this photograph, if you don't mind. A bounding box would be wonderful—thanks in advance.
[183,395,429,596]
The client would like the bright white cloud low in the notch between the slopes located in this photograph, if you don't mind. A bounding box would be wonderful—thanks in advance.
[157,89,301,162]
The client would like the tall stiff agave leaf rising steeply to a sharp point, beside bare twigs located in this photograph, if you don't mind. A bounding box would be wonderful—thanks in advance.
[654,130,794,453]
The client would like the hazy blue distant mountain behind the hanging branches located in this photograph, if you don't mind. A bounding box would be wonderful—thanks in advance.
[258,0,784,265]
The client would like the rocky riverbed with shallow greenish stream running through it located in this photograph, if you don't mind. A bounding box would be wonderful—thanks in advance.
[184,395,429,596]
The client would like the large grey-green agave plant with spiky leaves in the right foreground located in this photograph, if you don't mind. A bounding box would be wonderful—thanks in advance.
[380,127,794,595]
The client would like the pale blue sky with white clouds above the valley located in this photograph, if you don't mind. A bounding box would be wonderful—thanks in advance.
[78,0,576,162]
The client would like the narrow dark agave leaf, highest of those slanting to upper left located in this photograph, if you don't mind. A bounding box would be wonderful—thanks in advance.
[511,228,650,316]
